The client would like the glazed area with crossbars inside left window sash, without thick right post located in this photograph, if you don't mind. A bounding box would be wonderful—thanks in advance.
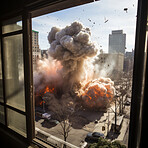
[1,17,26,137]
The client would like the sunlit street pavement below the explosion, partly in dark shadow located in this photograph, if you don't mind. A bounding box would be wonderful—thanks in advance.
[35,107,129,146]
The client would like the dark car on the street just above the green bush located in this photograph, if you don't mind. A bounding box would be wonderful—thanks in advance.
[85,132,105,143]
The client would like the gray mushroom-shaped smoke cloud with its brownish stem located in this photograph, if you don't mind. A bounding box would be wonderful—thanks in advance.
[48,22,97,88]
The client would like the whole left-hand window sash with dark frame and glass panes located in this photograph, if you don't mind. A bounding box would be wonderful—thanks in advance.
[0,15,33,140]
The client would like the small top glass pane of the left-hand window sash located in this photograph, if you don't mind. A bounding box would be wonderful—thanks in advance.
[2,16,22,34]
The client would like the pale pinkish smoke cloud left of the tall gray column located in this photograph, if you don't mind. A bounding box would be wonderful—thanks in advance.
[33,57,63,92]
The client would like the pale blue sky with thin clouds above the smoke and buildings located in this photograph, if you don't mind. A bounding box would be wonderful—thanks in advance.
[32,0,137,52]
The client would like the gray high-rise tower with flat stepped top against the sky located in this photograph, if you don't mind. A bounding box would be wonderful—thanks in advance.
[109,30,126,54]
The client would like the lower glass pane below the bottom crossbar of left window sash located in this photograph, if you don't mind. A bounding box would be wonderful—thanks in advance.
[7,109,26,137]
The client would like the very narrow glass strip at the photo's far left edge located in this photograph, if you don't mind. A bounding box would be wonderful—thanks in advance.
[0,41,4,102]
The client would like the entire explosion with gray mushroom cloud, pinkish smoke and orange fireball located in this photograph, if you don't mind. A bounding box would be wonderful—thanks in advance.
[34,22,114,109]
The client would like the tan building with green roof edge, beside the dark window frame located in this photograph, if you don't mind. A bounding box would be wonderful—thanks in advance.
[32,30,41,69]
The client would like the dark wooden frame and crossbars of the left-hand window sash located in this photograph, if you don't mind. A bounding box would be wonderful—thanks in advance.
[0,11,35,144]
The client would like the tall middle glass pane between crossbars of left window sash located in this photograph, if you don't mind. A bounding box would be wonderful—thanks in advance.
[3,34,25,111]
